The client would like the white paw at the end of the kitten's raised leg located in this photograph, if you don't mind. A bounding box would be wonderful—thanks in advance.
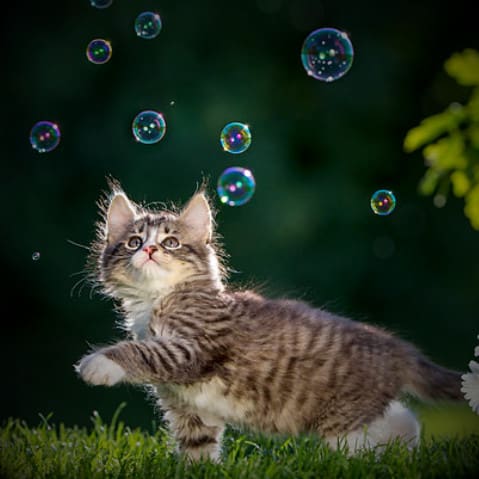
[75,353,126,386]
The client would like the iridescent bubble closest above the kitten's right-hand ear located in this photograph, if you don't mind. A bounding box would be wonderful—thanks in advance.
[216,166,256,206]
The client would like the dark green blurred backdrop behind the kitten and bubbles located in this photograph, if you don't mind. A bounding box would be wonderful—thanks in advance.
[0,0,479,432]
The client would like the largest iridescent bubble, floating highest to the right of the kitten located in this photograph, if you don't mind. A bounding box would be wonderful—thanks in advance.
[301,28,354,82]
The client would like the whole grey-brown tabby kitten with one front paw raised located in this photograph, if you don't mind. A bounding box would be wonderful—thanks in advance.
[76,184,463,460]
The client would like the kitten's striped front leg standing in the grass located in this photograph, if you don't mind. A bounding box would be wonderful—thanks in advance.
[165,407,224,462]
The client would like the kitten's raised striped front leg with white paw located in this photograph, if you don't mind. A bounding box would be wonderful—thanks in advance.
[75,337,202,386]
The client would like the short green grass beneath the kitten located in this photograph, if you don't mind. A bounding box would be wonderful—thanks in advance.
[0,408,479,479]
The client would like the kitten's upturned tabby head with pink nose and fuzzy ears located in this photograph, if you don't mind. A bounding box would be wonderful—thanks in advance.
[91,183,227,298]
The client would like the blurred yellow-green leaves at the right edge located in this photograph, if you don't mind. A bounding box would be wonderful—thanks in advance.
[404,49,479,230]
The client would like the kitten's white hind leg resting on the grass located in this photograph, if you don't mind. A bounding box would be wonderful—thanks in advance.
[326,401,421,454]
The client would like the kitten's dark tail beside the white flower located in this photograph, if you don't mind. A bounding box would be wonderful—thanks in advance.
[405,356,464,401]
